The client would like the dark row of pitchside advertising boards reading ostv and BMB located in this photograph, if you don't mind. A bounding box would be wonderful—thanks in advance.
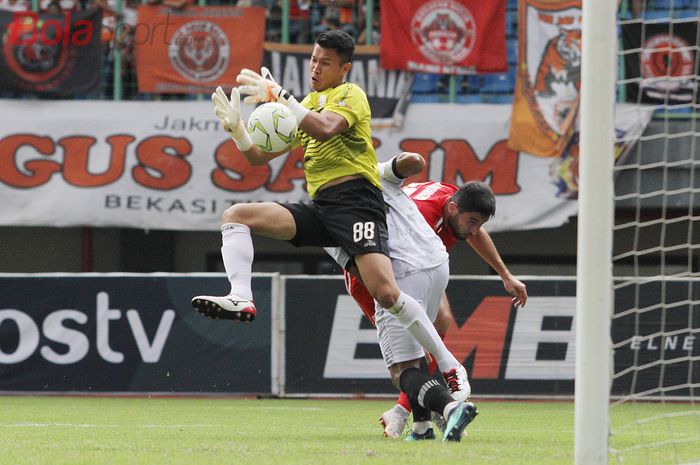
[0,273,700,396]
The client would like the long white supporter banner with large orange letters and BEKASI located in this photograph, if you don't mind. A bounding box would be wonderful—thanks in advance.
[0,100,577,232]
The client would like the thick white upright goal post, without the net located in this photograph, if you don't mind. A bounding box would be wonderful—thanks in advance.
[574,0,617,465]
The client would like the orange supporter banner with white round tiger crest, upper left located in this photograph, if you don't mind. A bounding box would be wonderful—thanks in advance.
[134,5,265,93]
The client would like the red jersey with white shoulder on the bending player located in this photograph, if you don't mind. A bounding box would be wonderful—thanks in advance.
[403,182,459,251]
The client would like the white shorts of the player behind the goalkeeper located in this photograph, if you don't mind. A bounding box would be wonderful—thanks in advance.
[376,261,450,368]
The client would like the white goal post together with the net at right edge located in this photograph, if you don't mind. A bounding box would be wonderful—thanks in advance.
[574,0,700,465]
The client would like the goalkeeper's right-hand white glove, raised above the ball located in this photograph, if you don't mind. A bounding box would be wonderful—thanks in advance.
[236,66,309,124]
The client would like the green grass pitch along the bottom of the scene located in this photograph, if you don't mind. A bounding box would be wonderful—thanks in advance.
[0,396,700,465]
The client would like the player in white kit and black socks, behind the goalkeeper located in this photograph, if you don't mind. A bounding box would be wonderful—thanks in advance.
[326,153,477,440]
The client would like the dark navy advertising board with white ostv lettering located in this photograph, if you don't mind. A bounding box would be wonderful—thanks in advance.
[0,274,273,393]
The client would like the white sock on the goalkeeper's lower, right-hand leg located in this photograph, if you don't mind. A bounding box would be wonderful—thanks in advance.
[387,291,459,372]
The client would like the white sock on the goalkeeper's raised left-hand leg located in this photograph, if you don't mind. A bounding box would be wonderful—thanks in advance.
[221,223,253,300]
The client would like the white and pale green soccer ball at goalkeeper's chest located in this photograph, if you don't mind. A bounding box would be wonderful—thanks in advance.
[247,102,297,152]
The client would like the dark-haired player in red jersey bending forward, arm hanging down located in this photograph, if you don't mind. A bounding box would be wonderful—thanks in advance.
[345,162,527,437]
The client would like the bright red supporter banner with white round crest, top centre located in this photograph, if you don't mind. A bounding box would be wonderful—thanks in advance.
[380,0,508,74]
